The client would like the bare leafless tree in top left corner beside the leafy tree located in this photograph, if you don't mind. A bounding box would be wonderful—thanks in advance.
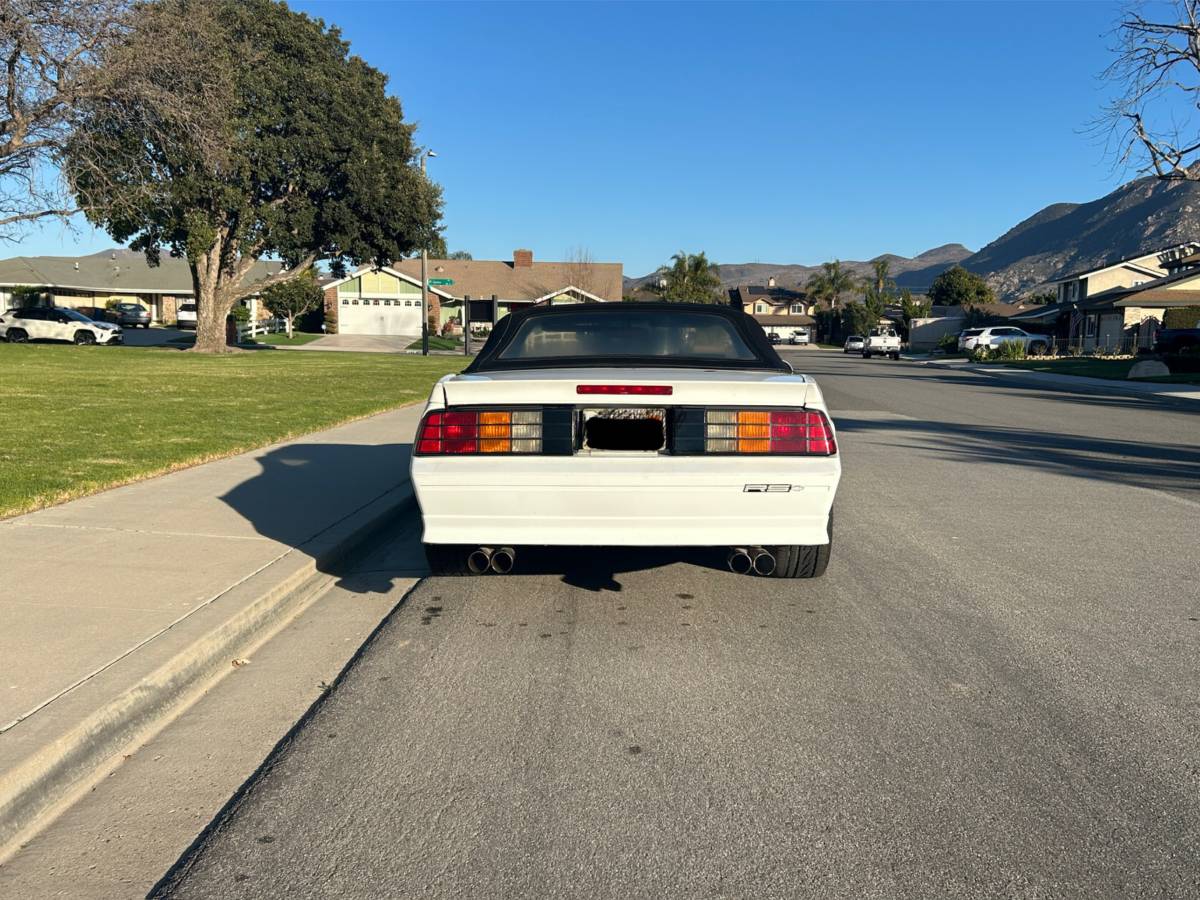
[0,0,230,240]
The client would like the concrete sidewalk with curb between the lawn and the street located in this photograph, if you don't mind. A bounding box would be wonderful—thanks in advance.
[0,406,421,856]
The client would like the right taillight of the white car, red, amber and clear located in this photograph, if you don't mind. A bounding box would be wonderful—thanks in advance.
[704,409,838,456]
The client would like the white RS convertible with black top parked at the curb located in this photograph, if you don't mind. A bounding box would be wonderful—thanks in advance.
[412,302,841,578]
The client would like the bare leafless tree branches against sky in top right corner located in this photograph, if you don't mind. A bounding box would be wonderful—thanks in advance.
[1100,0,1200,181]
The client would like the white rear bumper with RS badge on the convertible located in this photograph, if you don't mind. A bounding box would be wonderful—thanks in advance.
[413,456,841,546]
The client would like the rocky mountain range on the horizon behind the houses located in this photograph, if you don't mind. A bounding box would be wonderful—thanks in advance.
[625,178,1200,299]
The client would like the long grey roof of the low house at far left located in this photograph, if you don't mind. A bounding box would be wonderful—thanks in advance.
[0,250,283,295]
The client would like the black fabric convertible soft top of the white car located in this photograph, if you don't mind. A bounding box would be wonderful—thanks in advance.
[463,301,792,374]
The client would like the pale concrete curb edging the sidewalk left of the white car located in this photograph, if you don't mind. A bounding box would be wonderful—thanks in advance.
[0,481,414,862]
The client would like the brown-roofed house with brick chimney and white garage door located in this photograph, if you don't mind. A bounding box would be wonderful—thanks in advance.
[323,250,623,335]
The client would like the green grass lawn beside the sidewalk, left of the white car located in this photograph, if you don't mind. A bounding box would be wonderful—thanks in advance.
[0,343,466,517]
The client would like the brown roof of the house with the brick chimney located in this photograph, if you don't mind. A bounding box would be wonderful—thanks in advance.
[391,259,623,301]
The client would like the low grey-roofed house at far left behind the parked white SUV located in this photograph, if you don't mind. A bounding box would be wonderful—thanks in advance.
[0,250,283,324]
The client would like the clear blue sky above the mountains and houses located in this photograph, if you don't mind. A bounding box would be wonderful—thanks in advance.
[18,1,1129,275]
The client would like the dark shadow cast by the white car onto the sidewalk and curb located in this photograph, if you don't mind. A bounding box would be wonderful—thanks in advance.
[221,443,424,593]
